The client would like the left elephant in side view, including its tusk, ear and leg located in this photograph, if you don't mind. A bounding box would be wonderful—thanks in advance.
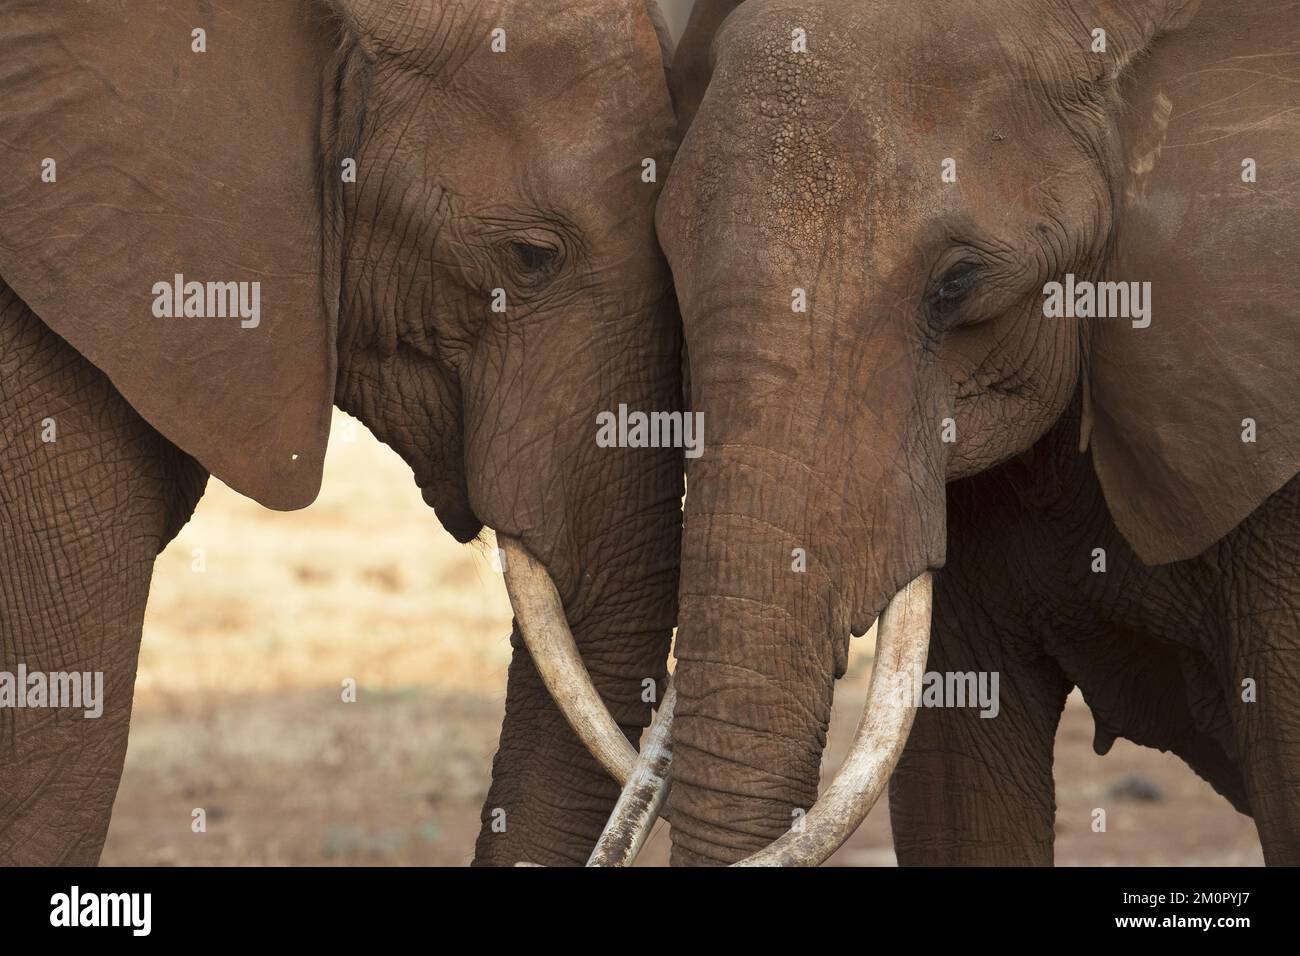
[0,0,683,865]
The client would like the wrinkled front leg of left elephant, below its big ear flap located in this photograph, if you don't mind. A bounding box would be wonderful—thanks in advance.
[0,284,207,865]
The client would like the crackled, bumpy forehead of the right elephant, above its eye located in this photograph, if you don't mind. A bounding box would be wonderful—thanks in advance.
[670,0,1082,251]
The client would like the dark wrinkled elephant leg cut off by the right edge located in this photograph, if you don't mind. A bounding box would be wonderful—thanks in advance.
[1214,479,1300,866]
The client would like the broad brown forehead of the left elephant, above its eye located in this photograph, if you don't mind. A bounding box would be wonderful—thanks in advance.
[369,0,675,228]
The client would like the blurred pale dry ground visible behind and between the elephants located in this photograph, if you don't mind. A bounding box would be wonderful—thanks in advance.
[103,0,1262,866]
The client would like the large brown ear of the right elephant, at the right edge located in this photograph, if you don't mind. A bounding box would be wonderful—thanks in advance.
[1088,0,1300,564]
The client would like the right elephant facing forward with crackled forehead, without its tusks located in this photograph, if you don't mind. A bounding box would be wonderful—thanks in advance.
[659,0,1300,864]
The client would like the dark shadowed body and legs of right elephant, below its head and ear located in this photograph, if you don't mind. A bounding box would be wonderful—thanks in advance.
[889,403,1300,866]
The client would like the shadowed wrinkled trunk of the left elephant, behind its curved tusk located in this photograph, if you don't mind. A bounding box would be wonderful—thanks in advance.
[469,298,683,865]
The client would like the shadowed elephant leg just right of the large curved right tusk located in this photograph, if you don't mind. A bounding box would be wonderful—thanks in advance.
[889,574,1070,866]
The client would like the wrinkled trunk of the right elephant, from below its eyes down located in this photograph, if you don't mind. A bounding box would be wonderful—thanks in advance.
[670,306,944,865]
